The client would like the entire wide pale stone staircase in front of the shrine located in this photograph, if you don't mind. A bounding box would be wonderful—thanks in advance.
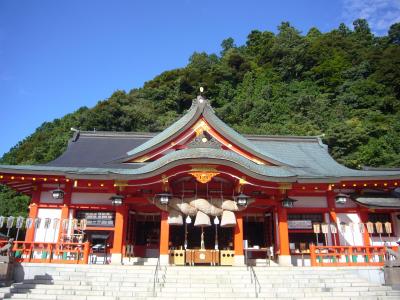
[0,264,400,300]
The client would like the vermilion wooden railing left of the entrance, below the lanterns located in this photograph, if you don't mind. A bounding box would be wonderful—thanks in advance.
[0,241,90,264]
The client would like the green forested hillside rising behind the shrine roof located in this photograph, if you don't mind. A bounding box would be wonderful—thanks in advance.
[0,19,400,214]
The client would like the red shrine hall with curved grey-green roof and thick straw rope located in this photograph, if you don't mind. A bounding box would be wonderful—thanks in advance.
[0,96,400,265]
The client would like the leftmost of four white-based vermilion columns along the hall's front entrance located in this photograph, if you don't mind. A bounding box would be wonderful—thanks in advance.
[111,205,128,264]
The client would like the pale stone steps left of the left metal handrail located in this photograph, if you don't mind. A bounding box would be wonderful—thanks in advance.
[0,264,155,300]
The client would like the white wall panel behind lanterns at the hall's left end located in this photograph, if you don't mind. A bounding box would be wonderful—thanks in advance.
[32,208,61,243]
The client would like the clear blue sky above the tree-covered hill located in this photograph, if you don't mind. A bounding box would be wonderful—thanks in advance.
[0,0,400,156]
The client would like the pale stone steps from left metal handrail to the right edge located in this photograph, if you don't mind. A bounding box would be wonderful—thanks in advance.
[151,267,400,300]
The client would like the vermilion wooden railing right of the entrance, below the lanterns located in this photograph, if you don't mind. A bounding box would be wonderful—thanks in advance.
[310,245,397,267]
